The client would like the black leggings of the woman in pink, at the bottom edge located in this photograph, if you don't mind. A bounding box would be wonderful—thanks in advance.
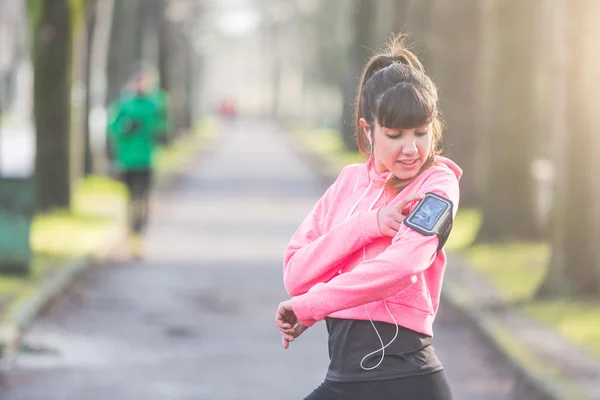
[304,370,452,400]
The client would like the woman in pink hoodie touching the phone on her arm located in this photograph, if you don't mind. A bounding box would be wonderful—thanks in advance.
[275,37,462,400]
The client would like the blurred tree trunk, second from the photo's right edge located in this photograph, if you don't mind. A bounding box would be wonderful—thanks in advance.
[478,0,538,241]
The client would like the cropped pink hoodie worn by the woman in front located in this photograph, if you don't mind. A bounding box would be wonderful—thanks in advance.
[284,156,462,336]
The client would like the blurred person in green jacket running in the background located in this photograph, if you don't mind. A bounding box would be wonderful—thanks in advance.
[108,62,169,257]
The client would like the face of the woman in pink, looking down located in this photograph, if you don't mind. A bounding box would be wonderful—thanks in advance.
[361,121,433,180]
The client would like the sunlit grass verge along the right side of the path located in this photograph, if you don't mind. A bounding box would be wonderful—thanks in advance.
[294,129,600,360]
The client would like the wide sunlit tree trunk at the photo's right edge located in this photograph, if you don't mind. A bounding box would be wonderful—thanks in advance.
[537,0,600,297]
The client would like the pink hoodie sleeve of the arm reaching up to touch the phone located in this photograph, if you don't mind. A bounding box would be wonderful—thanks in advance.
[283,167,381,296]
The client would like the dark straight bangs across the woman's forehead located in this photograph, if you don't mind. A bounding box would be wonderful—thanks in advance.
[375,83,436,129]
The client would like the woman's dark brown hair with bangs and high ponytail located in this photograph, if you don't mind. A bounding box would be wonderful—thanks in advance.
[355,35,442,191]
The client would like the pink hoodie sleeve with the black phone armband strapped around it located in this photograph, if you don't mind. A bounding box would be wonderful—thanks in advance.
[292,171,459,326]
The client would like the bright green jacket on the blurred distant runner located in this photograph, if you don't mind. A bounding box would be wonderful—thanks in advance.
[108,91,168,170]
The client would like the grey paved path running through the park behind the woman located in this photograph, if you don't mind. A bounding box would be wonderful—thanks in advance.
[0,122,513,400]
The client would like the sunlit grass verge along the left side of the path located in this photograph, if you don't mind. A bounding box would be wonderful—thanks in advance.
[0,120,214,318]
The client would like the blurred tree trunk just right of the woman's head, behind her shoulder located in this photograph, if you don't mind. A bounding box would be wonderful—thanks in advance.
[430,0,483,206]
